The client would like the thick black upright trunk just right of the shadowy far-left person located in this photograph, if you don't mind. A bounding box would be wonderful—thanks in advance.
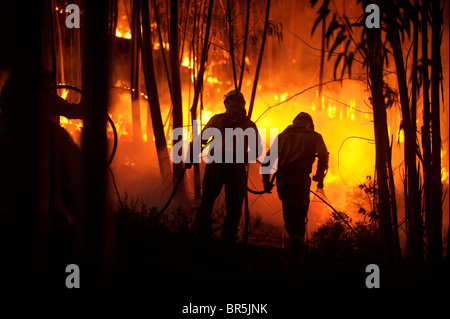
[77,0,112,295]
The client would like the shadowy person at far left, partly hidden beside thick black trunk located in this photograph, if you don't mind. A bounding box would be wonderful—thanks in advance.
[0,67,82,232]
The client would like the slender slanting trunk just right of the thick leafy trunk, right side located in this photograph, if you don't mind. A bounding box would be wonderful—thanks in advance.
[387,8,424,276]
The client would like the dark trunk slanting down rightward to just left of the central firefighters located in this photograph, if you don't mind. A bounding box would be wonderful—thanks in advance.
[138,0,171,179]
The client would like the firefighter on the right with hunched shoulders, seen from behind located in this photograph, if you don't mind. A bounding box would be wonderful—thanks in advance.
[263,112,328,253]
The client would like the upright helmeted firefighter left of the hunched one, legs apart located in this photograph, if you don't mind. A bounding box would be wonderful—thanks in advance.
[188,90,262,244]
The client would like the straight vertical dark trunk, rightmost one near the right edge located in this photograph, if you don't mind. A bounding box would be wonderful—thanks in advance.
[429,0,442,267]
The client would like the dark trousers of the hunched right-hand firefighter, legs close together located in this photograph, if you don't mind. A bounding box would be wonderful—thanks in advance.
[277,165,311,241]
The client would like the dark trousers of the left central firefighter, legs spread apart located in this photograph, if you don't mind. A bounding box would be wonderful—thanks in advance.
[193,163,247,242]
